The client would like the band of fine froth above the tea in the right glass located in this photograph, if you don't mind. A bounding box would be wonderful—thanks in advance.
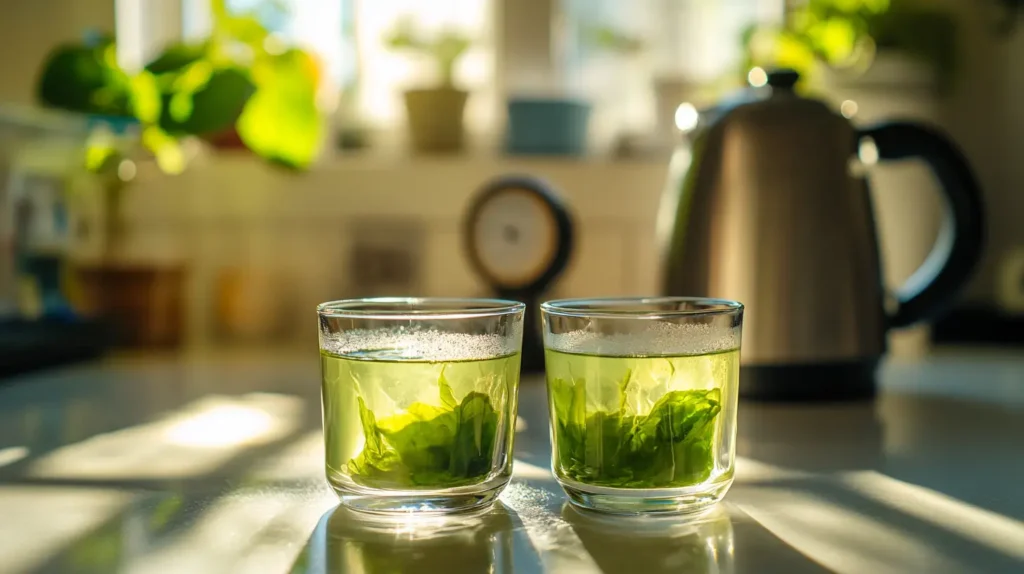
[546,321,739,357]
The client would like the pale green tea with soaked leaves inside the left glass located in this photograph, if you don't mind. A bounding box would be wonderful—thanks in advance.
[321,350,519,490]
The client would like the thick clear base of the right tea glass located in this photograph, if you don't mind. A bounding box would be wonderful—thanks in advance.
[558,477,732,515]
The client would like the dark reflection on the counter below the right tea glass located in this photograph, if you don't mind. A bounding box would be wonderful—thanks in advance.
[562,502,734,574]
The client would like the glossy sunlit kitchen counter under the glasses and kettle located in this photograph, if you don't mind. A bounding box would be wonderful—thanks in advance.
[0,352,1024,574]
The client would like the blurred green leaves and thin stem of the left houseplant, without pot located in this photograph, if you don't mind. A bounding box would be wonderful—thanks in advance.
[37,0,323,251]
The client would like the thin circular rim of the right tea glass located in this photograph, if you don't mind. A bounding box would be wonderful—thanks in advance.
[541,297,743,320]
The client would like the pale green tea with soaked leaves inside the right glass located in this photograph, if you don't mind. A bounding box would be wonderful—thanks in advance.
[546,350,739,488]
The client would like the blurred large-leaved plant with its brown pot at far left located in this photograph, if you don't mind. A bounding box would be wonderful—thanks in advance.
[38,0,323,346]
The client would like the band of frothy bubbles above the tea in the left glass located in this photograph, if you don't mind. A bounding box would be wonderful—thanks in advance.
[321,328,517,362]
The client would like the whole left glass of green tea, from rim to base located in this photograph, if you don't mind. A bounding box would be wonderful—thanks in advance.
[316,299,524,513]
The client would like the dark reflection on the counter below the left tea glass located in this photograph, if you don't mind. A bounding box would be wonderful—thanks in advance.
[291,502,523,574]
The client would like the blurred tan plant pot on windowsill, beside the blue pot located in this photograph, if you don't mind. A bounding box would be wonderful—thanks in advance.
[406,88,469,153]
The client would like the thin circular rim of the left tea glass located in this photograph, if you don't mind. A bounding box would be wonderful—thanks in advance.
[316,297,526,320]
